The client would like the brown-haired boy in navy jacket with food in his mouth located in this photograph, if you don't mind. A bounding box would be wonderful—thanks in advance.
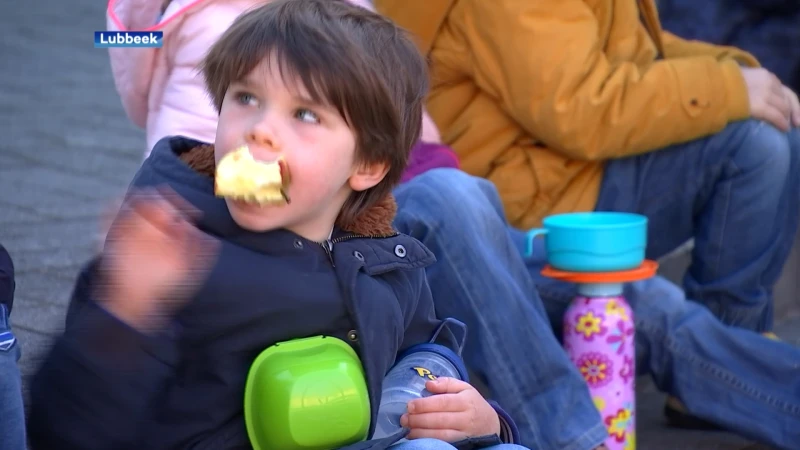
[29,0,520,450]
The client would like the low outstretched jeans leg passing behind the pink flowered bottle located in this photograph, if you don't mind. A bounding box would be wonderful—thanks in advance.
[510,229,800,448]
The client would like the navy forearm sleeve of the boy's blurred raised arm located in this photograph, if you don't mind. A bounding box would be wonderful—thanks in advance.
[28,262,177,450]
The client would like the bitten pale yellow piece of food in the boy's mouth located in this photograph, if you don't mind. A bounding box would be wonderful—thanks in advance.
[214,146,289,206]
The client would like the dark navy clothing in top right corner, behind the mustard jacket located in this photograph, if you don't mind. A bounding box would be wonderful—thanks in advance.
[658,0,800,91]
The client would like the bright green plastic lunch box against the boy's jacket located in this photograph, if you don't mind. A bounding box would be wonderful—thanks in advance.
[244,336,370,450]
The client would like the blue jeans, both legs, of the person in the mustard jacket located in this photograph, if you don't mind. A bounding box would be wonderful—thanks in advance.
[510,121,800,448]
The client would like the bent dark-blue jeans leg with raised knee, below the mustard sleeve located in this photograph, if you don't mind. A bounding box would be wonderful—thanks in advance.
[597,120,800,332]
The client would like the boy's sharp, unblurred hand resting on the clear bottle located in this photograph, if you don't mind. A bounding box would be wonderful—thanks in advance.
[400,377,500,442]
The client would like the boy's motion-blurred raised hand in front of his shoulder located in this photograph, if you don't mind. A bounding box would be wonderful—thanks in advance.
[102,186,216,331]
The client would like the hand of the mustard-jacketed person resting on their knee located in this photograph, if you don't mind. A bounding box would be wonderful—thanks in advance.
[742,67,792,131]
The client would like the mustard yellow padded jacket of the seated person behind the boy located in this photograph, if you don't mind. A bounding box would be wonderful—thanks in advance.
[375,0,758,228]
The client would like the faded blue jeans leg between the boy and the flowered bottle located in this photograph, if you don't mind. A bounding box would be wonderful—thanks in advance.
[395,169,607,450]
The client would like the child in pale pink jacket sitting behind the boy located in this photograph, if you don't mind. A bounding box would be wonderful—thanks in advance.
[107,0,440,158]
